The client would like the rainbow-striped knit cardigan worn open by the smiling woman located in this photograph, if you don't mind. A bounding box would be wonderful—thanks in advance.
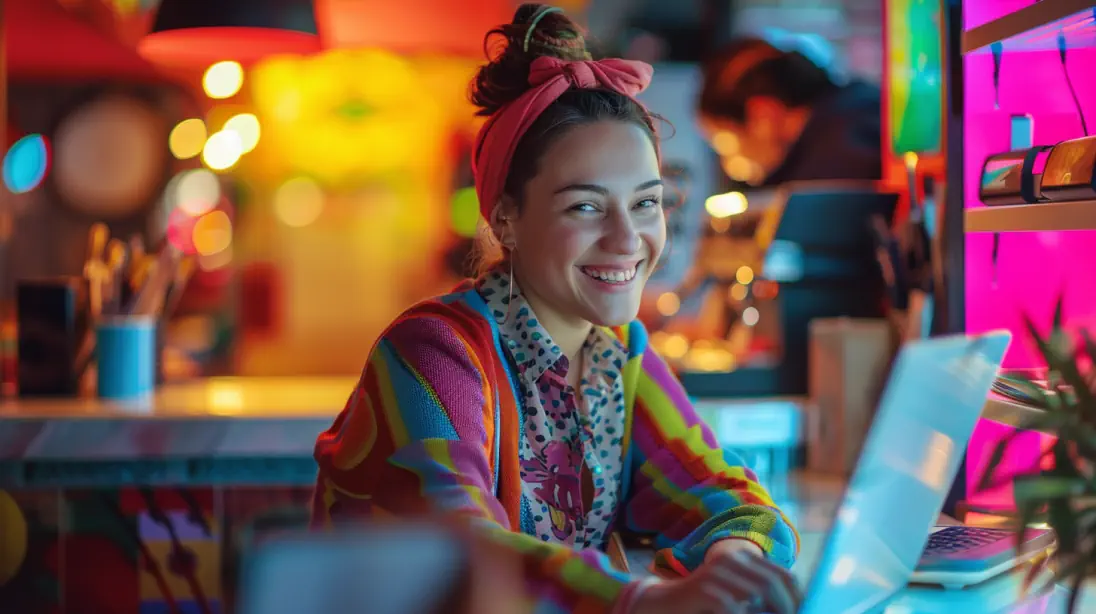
[312,286,799,613]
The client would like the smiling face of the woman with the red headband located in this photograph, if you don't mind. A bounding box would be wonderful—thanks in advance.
[509,121,666,326]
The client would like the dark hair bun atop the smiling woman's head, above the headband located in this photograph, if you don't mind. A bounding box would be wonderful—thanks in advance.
[469,2,590,115]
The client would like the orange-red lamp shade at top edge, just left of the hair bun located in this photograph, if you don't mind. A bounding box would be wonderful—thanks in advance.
[315,0,508,57]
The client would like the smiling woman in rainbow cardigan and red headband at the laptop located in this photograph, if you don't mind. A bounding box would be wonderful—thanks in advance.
[312,4,800,614]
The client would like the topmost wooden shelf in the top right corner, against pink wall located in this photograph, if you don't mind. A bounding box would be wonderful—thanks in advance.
[962,0,1096,54]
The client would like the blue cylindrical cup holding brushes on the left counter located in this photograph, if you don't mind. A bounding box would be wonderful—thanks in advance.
[95,316,157,400]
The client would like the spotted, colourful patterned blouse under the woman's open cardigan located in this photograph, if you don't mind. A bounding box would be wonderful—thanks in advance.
[477,271,628,548]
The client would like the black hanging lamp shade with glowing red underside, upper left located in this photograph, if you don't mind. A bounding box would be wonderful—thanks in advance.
[138,0,320,67]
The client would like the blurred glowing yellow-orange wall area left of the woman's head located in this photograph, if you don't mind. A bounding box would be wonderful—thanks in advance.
[235,50,475,374]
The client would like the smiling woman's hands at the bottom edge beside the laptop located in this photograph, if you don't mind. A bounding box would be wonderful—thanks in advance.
[631,548,802,614]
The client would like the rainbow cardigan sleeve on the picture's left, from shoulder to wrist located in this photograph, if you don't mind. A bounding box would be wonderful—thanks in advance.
[312,316,635,614]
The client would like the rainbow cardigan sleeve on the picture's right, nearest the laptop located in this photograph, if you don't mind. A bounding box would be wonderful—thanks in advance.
[625,332,799,573]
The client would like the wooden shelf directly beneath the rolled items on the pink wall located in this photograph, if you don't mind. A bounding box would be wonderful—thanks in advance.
[963,201,1096,232]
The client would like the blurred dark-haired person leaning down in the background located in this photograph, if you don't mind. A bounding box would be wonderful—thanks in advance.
[698,33,882,186]
